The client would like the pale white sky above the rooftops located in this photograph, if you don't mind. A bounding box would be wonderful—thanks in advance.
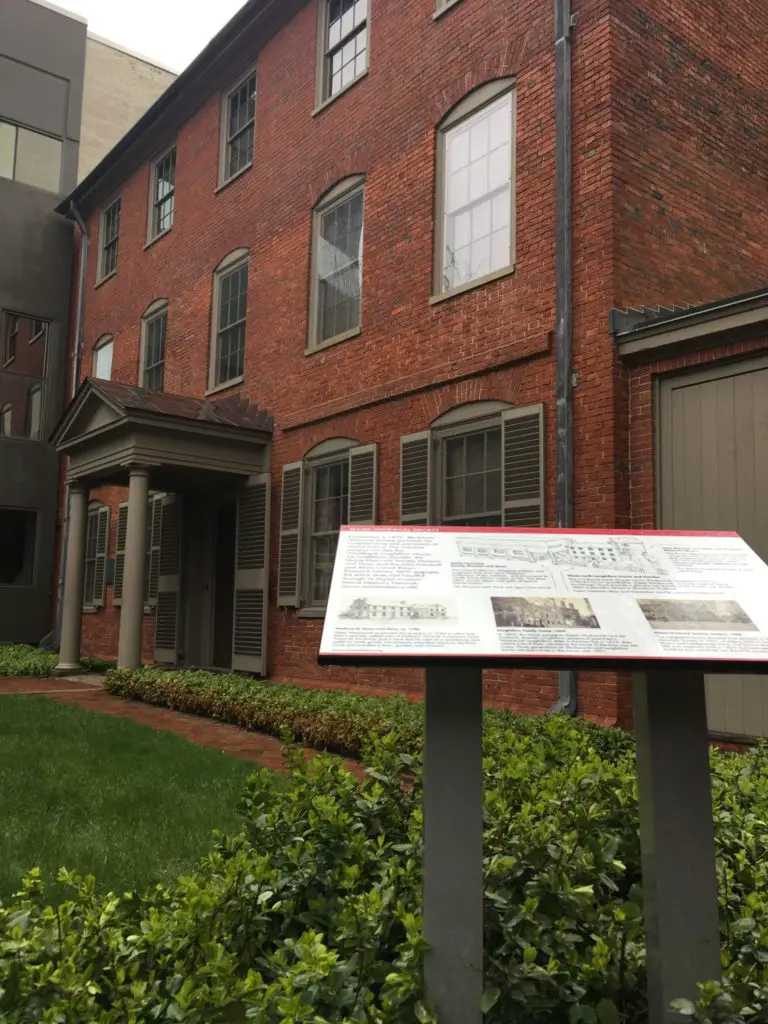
[51,0,245,72]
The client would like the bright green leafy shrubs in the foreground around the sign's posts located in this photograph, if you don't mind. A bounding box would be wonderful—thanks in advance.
[0,716,768,1024]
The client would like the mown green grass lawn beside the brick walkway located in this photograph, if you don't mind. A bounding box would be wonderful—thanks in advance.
[0,695,255,900]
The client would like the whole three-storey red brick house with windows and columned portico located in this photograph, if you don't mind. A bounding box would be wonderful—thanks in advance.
[49,0,768,731]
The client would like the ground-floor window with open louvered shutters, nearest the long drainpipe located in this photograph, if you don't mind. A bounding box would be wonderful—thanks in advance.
[400,401,544,526]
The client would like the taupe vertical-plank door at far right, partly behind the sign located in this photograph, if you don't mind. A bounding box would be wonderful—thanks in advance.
[657,358,768,736]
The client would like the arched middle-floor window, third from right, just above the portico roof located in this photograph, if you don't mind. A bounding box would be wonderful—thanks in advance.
[211,249,248,387]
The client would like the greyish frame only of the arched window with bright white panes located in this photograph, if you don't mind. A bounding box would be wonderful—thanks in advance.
[430,78,517,303]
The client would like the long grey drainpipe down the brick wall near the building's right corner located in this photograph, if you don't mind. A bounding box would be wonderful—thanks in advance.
[548,0,579,715]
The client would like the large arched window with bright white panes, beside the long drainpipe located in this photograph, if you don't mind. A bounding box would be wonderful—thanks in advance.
[435,80,515,294]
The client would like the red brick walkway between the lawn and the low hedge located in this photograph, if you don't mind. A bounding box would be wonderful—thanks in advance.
[0,677,362,775]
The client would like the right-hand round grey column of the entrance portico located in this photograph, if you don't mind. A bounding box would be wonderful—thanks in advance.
[118,469,150,669]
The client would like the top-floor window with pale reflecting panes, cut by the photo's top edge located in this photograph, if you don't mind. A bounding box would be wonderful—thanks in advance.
[317,0,369,103]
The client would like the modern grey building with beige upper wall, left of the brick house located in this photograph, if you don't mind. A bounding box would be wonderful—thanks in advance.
[0,0,174,642]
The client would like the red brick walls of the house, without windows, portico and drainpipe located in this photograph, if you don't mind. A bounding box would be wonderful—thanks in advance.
[61,0,768,723]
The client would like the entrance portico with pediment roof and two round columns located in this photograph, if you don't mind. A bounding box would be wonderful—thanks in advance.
[52,379,272,674]
